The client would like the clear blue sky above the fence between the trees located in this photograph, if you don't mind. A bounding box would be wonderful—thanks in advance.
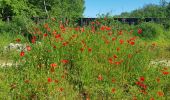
[84,0,170,17]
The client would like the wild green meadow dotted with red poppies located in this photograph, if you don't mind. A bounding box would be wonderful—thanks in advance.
[0,18,170,100]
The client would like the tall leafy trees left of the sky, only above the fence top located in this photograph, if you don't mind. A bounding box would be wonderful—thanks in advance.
[0,0,85,20]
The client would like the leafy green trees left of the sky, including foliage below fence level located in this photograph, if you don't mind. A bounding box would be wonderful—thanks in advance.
[0,0,85,33]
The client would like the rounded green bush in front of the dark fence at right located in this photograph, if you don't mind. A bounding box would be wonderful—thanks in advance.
[135,22,163,39]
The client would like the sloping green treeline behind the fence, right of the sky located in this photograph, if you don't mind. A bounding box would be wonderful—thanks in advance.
[116,0,170,18]
